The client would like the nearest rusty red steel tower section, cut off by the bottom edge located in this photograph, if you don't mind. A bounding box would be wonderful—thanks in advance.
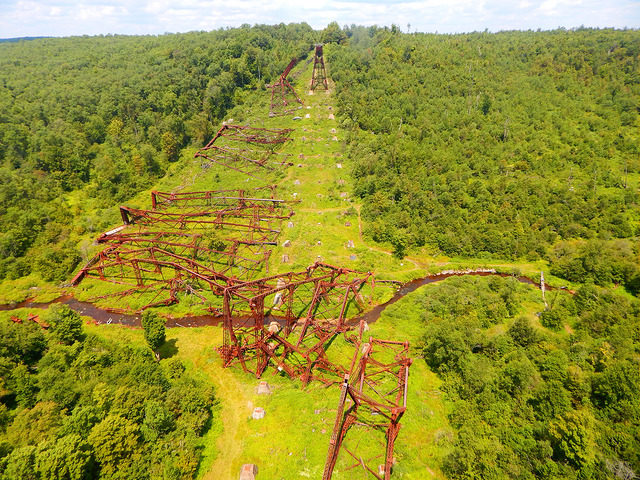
[322,336,412,480]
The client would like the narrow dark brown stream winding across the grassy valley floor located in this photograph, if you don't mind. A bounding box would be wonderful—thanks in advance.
[0,271,553,328]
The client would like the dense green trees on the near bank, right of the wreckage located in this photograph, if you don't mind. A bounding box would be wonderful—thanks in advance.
[382,277,640,479]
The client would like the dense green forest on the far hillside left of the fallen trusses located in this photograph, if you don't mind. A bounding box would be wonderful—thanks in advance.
[0,24,315,282]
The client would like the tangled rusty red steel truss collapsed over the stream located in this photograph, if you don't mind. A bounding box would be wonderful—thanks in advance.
[220,262,374,384]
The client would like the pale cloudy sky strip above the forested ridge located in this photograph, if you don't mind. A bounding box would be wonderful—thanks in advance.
[0,0,640,38]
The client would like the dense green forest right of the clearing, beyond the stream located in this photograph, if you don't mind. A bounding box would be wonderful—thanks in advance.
[330,27,640,281]
